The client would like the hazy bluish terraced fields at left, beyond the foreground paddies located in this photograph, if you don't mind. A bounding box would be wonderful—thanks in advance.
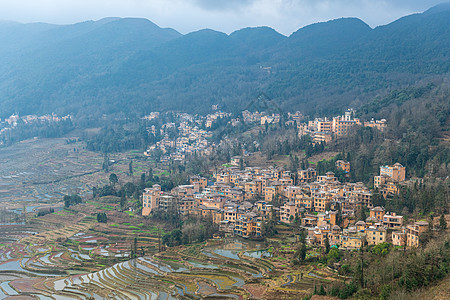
[0,136,154,204]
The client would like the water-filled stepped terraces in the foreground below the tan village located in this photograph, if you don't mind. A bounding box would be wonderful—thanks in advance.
[0,202,336,299]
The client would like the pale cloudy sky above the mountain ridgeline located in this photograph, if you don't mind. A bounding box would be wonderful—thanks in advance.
[0,0,446,35]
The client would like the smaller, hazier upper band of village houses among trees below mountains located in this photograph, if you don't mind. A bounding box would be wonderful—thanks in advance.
[143,106,387,162]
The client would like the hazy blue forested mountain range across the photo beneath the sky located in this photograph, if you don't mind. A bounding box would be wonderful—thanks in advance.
[0,4,450,119]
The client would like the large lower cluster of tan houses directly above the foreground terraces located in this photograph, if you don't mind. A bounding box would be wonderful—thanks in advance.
[142,162,428,249]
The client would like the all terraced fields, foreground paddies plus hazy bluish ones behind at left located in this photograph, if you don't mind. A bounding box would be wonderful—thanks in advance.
[0,139,342,299]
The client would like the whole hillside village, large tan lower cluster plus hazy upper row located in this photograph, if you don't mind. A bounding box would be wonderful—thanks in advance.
[142,107,428,249]
